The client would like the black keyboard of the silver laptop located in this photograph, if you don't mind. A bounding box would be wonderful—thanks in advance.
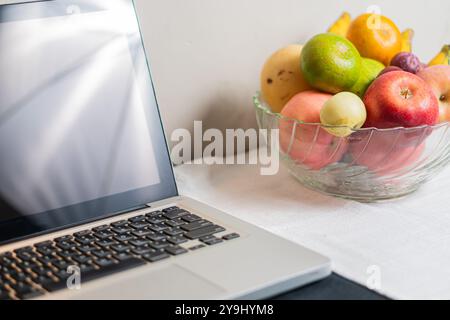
[0,207,239,300]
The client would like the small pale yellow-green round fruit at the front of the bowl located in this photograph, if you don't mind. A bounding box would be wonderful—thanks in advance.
[320,92,367,137]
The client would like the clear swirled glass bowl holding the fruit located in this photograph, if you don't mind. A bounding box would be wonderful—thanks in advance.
[253,92,450,202]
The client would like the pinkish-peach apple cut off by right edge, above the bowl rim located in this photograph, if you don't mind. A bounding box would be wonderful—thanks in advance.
[417,65,450,122]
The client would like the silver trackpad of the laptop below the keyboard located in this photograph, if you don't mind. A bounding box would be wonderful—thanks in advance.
[73,265,225,300]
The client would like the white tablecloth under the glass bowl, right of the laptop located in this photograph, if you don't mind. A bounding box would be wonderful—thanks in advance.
[175,153,450,299]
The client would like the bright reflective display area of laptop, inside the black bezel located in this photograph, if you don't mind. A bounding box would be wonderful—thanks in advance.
[0,10,161,220]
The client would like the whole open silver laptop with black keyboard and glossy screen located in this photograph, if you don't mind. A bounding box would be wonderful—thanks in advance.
[0,0,330,299]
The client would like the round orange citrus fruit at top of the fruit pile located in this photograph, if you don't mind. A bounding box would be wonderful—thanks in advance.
[347,13,402,65]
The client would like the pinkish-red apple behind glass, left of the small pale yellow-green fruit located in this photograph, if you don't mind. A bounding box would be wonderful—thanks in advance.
[279,91,347,170]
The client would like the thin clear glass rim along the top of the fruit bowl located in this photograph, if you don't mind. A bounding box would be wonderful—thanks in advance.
[253,91,450,133]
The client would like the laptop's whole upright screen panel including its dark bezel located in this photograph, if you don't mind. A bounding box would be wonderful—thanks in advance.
[0,0,177,242]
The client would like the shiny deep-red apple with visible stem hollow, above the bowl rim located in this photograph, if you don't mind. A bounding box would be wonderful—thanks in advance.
[364,71,439,128]
